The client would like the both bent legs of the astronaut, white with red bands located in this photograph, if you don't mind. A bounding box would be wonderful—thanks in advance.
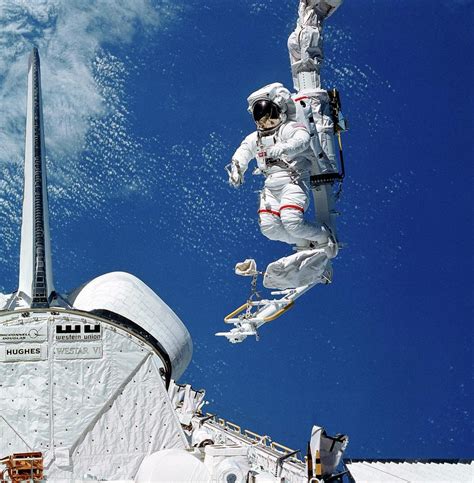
[258,183,328,246]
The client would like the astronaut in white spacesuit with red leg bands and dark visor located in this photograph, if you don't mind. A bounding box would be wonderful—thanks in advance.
[228,83,334,256]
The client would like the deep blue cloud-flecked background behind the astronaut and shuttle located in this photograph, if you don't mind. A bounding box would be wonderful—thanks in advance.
[0,0,473,458]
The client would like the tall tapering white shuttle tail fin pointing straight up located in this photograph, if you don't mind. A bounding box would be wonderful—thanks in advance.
[17,47,54,308]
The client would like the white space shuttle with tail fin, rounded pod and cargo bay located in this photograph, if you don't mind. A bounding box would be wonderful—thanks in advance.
[0,49,347,483]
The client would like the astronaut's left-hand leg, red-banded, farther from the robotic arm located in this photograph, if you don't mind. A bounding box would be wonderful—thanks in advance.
[258,187,302,244]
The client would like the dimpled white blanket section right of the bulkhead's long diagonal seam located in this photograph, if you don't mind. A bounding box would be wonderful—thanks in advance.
[54,356,187,479]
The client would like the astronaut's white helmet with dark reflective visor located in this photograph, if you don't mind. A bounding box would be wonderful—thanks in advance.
[247,82,293,133]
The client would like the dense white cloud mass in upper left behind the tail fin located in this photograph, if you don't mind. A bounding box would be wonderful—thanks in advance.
[0,0,176,162]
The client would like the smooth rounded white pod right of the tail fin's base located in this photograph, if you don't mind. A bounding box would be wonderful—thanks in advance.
[70,272,192,379]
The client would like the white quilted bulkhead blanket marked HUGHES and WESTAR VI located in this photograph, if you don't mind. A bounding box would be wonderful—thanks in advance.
[0,313,188,481]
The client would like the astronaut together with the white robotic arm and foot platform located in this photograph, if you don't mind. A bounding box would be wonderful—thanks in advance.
[216,0,347,343]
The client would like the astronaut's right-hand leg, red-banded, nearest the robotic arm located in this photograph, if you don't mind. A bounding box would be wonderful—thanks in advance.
[280,183,337,258]
